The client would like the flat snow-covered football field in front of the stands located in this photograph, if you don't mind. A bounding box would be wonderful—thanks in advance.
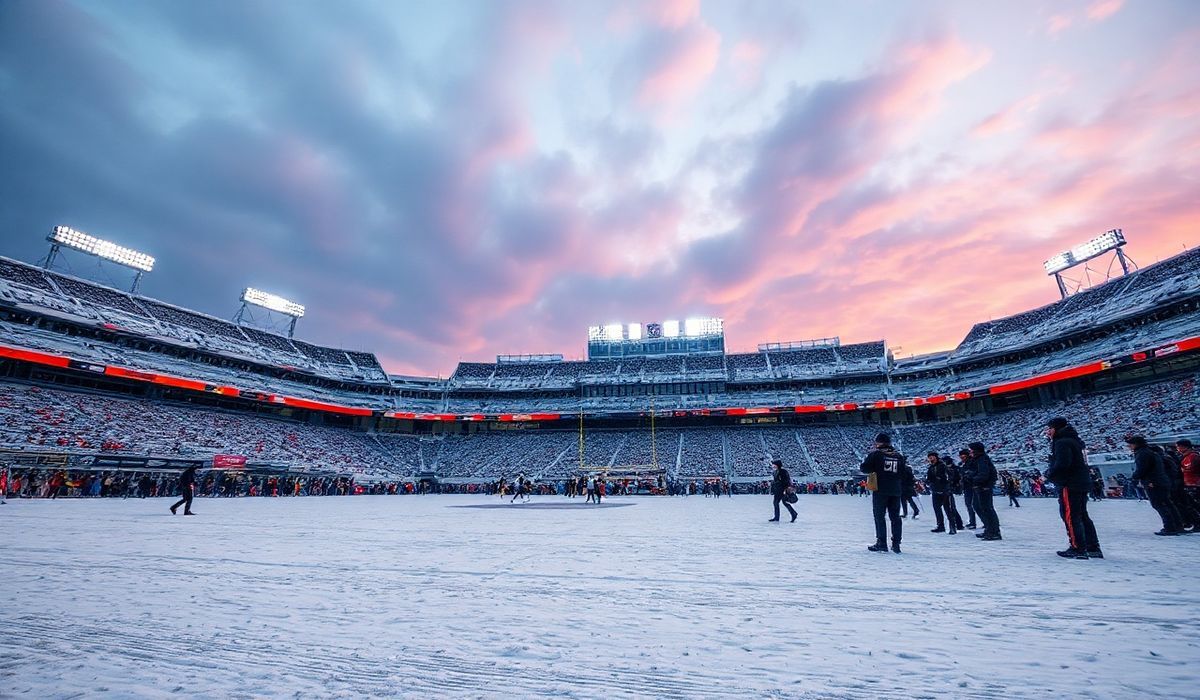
[0,496,1200,698]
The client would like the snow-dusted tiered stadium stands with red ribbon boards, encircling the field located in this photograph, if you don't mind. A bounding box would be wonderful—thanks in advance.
[0,227,1200,492]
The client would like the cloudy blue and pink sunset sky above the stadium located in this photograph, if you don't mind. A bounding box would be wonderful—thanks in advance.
[0,0,1200,376]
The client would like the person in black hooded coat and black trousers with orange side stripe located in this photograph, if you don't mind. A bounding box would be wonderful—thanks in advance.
[1044,417,1104,560]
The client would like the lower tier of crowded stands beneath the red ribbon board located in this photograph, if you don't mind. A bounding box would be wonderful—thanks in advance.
[0,376,1200,481]
